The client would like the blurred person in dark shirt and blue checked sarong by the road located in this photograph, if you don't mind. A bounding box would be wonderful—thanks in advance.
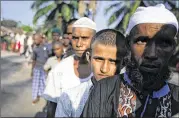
[31,33,48,104]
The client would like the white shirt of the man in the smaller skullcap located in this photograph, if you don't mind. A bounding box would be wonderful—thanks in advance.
[42,55,92,102]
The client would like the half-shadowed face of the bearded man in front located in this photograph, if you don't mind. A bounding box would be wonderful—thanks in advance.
[130,23,175,74]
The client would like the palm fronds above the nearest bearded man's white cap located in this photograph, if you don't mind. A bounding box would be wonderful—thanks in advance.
[105,0,179,33]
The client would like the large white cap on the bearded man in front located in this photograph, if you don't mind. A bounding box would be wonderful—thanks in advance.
[125,4,178,35]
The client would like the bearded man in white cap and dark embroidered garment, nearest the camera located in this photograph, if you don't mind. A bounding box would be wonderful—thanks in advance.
[81,4,179,117]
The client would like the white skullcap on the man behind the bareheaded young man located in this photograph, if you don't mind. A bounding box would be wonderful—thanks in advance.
[72,17,96,31]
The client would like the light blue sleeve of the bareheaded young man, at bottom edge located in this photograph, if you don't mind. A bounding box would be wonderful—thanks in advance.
[55,93,72,117]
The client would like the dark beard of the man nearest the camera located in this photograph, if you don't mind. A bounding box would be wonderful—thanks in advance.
[124,54,171,93]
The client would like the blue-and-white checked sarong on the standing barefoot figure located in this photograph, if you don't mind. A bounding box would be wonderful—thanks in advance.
[32,68,46,100]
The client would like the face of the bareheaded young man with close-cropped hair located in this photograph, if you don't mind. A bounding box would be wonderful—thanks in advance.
[90,43,118,81]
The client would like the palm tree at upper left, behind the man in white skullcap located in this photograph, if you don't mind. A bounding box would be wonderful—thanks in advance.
[31,0,97,39]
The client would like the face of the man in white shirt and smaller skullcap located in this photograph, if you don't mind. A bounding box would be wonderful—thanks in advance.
[72,27,94,57]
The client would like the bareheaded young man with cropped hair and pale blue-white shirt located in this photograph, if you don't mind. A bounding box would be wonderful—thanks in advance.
[56,29,126,117]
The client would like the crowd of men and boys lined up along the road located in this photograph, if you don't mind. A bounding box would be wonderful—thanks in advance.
[7,4,179,118]
